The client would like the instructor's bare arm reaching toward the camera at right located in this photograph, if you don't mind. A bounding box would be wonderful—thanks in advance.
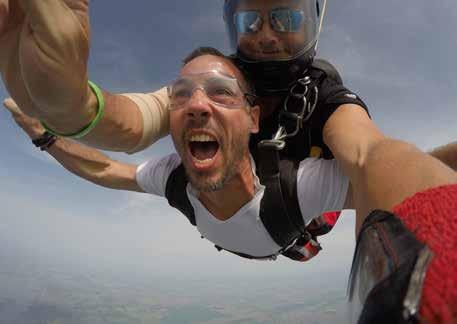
[324,105,457,233]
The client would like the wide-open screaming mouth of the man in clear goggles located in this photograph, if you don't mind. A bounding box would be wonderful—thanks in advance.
[188,134,219,164]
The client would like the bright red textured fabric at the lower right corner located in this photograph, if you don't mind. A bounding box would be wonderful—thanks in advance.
[393,185,457,323]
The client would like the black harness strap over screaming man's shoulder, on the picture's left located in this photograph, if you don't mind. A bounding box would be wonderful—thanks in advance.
[165,163,197,226]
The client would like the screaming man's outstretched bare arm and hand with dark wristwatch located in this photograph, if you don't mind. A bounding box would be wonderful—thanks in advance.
[4,100,143,192]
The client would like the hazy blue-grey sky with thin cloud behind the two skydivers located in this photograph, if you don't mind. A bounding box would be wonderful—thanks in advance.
[0,0,457,312]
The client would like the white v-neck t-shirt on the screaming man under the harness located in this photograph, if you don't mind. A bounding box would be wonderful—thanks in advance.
[136,153,349,257]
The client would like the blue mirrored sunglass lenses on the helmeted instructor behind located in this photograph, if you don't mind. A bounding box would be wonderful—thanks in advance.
[234,8,305,34]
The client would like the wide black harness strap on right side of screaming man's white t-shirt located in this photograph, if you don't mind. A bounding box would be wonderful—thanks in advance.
[258,142,305,248]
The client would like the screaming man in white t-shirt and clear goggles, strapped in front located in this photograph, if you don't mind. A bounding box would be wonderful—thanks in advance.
[6,49,349,261]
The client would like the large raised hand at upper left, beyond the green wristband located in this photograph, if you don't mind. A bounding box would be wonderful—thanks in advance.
[0,0,92,133]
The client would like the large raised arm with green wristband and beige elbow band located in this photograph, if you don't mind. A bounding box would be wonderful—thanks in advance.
[0,0,168,152]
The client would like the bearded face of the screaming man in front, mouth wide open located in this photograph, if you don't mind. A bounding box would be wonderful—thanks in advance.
[170,55,258,192]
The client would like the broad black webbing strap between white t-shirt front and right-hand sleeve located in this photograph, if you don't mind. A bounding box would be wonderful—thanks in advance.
[258,141,304,248]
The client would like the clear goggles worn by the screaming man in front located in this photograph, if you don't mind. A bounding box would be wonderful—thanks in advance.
[168,71,255,110]
